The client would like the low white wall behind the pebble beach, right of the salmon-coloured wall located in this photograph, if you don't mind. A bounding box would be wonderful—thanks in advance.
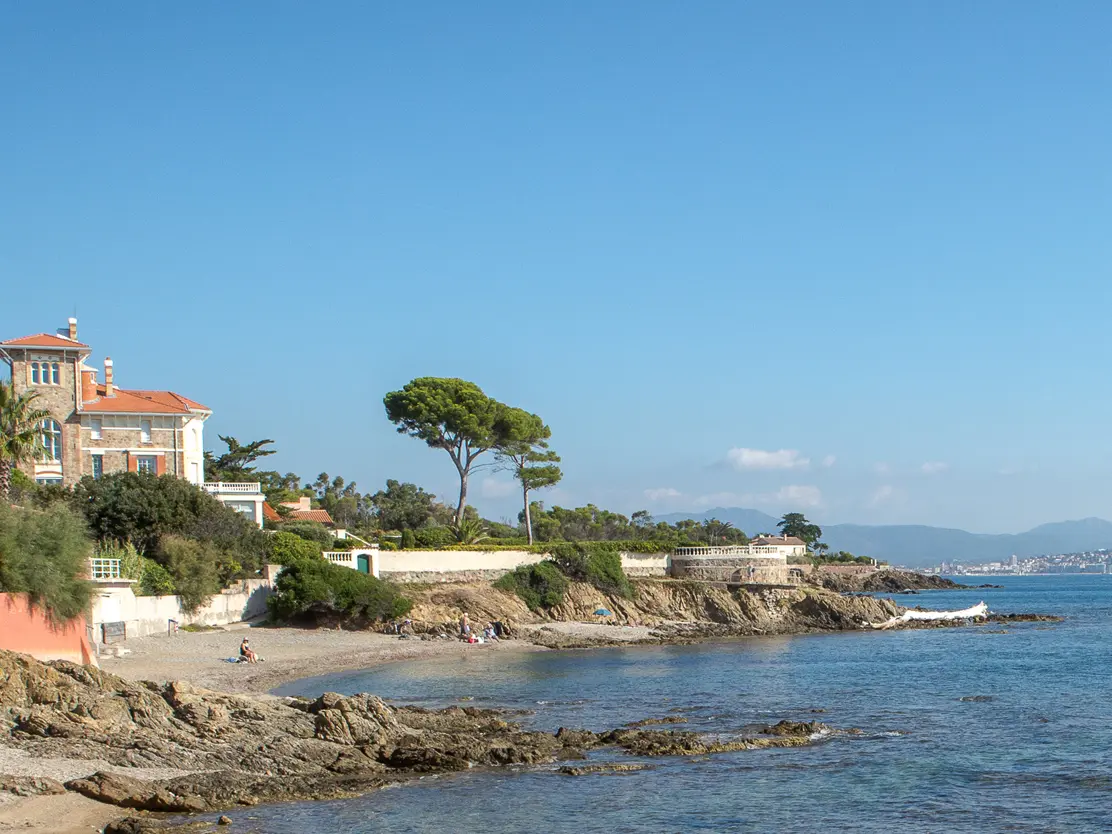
[91,579,274,643]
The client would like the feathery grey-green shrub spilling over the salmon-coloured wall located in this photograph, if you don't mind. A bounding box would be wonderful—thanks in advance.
[0,502,92,623]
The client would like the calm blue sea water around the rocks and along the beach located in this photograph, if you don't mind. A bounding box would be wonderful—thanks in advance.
[247,576,1112,834]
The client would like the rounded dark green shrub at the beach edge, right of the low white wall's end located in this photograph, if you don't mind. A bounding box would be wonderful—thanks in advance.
[267,559,413,623]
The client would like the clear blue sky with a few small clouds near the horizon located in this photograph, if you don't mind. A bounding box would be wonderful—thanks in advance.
[0,0,1112,532]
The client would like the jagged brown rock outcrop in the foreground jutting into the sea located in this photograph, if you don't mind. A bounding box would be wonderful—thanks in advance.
[0,652,849,818]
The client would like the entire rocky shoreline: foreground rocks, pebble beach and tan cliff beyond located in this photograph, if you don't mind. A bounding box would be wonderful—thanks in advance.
[0,580,1060,834]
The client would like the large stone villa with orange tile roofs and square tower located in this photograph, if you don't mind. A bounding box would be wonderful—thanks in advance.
[0,318,212,486]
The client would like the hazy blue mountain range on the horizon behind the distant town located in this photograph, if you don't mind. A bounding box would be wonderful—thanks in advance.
[655,507,1112,567]
